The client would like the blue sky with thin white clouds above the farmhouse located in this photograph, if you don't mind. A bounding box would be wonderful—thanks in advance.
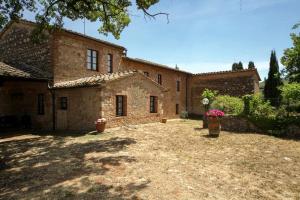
[25,0,300,79]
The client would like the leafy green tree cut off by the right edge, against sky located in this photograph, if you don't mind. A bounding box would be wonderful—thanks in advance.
[281,33,300,83]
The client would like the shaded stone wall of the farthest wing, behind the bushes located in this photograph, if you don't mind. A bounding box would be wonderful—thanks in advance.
[188,71,259,115]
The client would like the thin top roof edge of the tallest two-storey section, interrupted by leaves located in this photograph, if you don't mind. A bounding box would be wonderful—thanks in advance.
[0,19,126,50]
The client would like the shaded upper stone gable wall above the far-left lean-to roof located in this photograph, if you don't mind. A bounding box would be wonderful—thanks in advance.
[0,23,52,76]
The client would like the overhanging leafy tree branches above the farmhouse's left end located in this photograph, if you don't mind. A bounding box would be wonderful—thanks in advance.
[0,0,168,39]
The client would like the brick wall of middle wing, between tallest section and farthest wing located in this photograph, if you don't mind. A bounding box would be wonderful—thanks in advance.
[123,59,188,118]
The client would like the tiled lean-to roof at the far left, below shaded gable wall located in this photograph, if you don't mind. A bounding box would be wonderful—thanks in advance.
[0,62,50,80]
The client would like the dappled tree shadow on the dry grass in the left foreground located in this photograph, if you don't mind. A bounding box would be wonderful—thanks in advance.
[0,136,148,199]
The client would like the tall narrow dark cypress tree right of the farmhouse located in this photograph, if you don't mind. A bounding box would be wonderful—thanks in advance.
[264,51,282,107]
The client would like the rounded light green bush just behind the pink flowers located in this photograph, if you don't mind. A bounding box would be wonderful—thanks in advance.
[211,95,244,115]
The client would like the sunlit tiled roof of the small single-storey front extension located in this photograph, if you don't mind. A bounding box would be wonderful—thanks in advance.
[53,70,166,90]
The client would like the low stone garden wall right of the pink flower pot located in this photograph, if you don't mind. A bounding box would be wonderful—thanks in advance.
[221,116,264,133]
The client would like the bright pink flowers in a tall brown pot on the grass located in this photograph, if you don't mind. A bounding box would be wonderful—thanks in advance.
[205,109,224,137]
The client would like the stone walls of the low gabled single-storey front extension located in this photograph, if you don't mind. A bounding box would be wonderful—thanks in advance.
[55,75,165,130]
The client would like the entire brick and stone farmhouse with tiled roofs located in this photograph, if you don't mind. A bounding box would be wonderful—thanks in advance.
[0,20,260,130]
